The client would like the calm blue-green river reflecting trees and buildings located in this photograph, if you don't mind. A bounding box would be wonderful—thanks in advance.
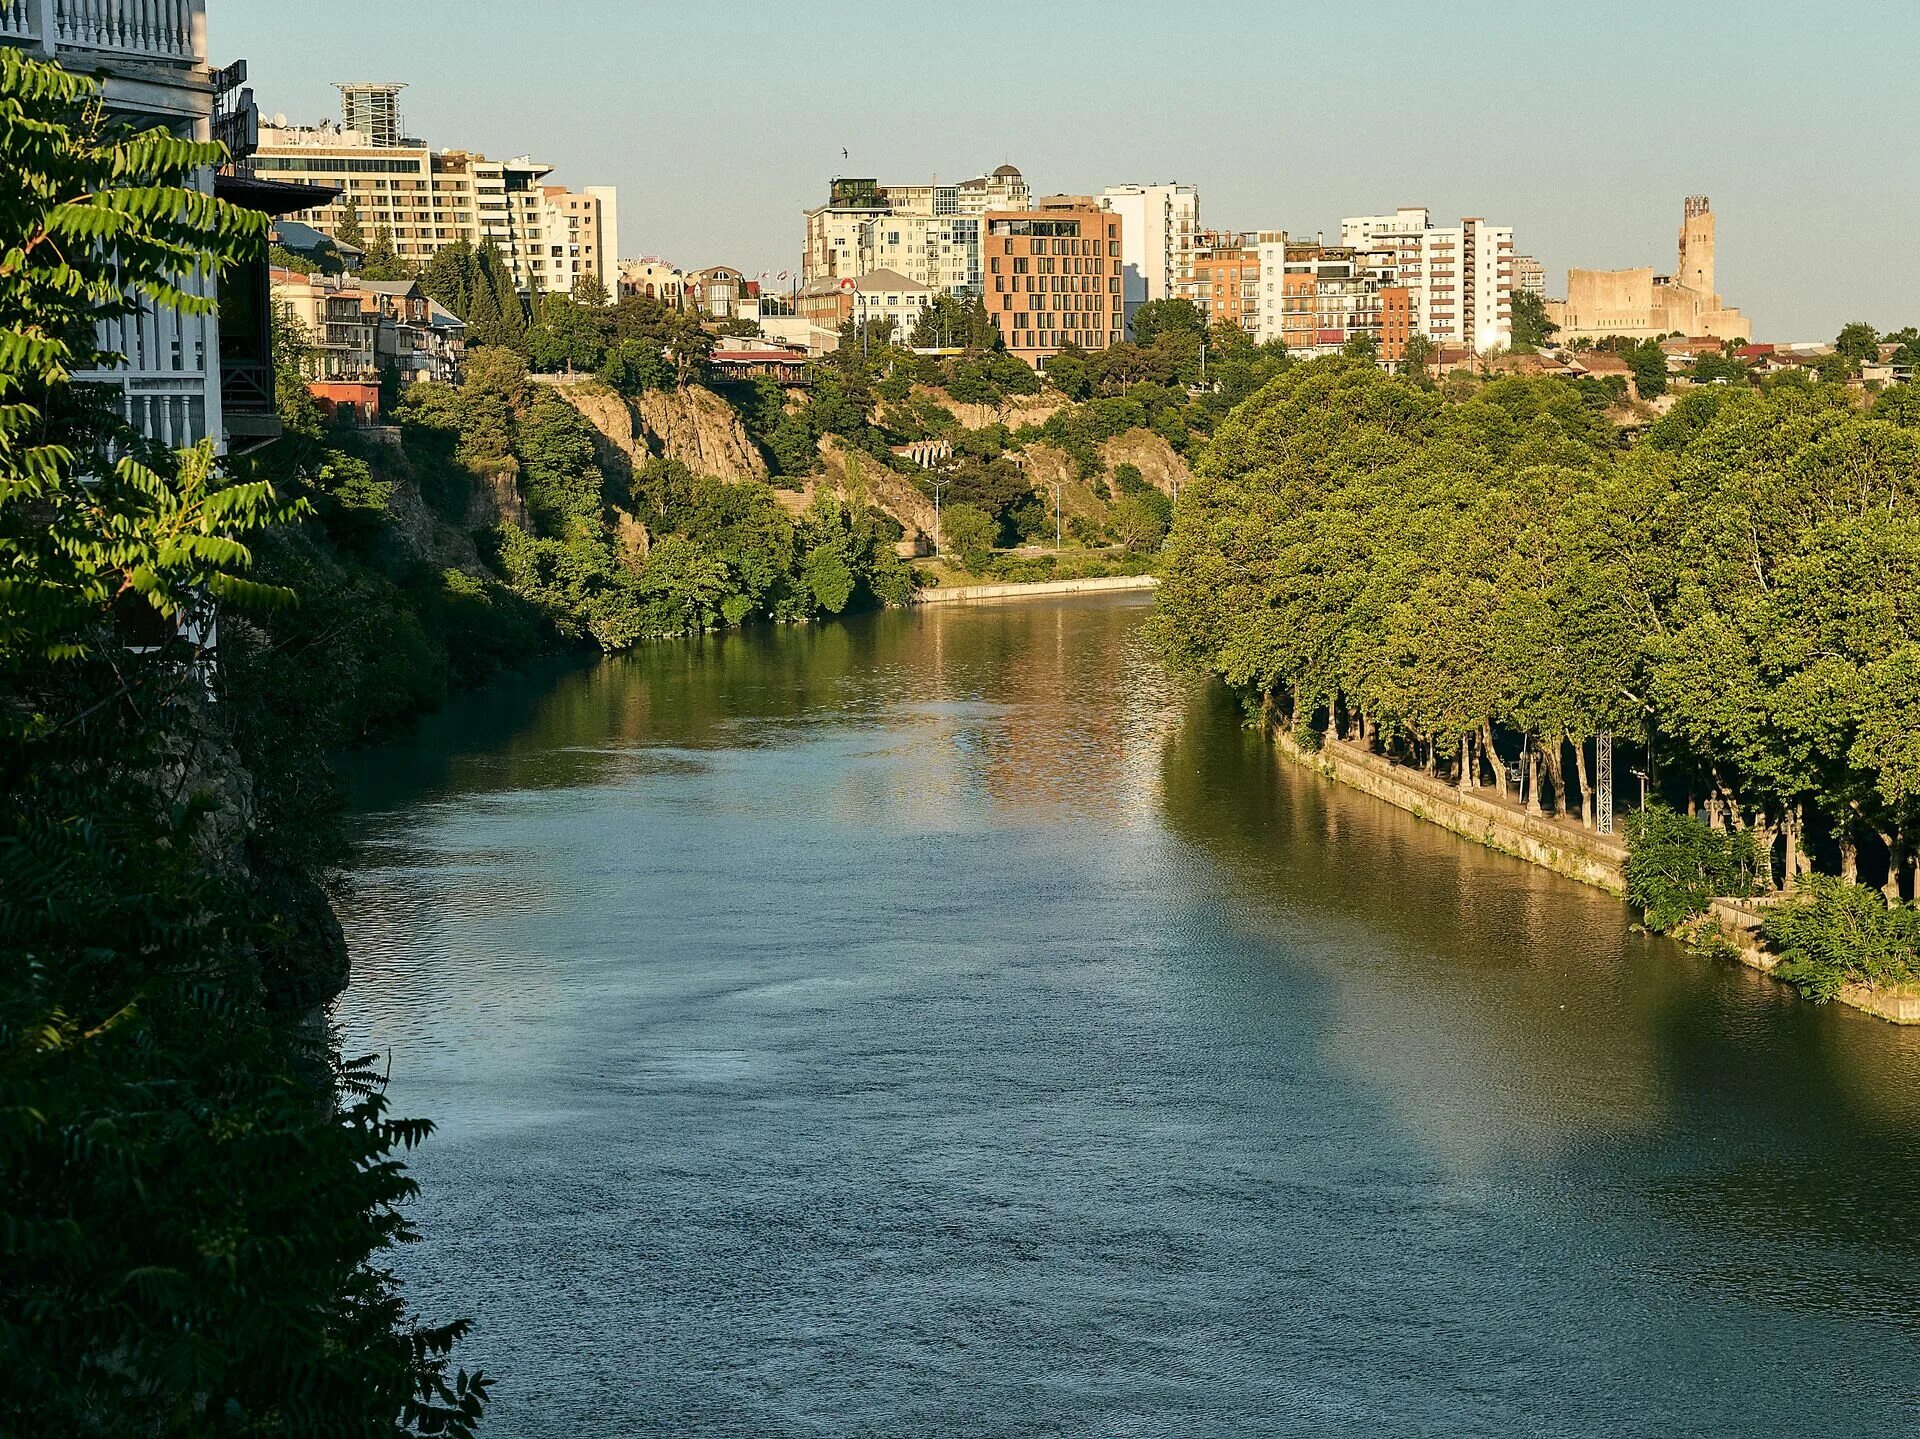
[338,598,1920,1439]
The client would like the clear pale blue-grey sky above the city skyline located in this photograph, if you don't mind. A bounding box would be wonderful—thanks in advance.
[220,0,1920,340]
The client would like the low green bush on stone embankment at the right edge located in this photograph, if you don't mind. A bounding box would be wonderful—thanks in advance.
[1761,874,1920,1003]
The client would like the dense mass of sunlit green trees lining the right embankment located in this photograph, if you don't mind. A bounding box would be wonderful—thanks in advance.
[1158,359,1920,922]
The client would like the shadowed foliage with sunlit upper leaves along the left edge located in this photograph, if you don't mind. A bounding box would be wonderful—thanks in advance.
[0,48,488,1435]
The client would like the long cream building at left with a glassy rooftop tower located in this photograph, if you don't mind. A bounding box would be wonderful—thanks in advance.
[253,83,618,294]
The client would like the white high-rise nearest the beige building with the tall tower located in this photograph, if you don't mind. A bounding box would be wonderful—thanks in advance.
[1340,207,1515,354]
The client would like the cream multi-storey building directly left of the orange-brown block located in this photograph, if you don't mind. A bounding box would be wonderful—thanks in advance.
[801,165,1031,296]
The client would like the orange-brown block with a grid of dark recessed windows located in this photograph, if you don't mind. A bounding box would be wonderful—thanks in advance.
[985,194,1127,369]
